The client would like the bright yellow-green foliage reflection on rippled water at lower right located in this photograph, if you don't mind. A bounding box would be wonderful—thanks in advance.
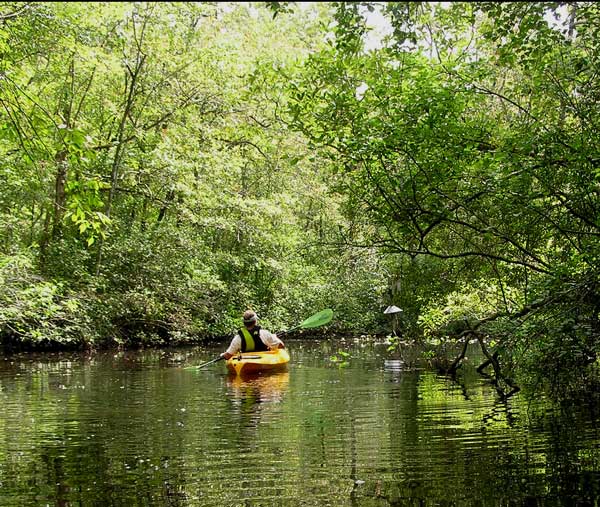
[365,372,568,504]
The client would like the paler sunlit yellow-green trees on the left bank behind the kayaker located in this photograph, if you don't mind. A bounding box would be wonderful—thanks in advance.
[0,3,370,346]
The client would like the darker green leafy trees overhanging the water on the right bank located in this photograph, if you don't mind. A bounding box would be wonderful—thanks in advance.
[288,2,600,396]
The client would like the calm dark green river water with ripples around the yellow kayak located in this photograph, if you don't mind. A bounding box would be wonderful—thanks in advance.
[0,341,600,506]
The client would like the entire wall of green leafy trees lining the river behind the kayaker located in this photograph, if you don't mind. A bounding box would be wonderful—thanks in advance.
[0,2,600,400]
